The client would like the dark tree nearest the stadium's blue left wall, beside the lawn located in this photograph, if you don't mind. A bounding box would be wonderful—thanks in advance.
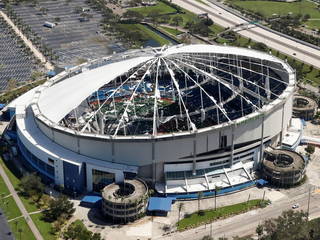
[19,173,44,202]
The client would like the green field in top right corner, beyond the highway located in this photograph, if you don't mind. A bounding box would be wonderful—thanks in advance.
[230,0,320,28]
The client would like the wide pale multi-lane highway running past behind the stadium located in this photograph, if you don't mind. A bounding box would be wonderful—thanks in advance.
[172,0,320,69]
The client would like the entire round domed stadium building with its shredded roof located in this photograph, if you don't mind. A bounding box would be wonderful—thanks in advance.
[16,45,295,194]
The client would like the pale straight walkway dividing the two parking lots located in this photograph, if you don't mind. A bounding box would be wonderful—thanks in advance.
[0,10,54,70]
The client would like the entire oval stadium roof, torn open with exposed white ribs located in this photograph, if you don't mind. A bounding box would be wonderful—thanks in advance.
[32,45,295,138]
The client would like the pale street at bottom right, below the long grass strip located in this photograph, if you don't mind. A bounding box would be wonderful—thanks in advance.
[159,188,320,240]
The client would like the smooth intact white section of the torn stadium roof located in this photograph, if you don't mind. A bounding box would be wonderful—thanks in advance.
[38,56,151,123]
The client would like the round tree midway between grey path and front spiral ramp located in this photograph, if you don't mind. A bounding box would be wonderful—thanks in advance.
[43,195,75,222]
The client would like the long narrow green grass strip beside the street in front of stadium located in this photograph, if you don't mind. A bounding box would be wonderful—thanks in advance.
[177,199,270,231]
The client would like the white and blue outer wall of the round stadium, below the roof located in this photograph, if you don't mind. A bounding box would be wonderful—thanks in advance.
[16,46,295,192]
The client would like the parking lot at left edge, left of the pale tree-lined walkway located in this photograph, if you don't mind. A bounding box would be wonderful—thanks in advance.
[0,17,39,92]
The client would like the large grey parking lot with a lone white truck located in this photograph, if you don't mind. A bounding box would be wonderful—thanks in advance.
[10,0,124,67]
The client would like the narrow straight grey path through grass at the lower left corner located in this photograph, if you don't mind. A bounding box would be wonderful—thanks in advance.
[0,162,43,240]
